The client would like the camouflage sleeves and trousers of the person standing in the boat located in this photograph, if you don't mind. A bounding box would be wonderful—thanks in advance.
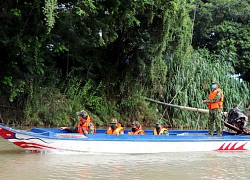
[207,91,223,135]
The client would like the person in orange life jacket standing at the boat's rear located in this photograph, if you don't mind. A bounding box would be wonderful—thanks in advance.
[203,82,224,135]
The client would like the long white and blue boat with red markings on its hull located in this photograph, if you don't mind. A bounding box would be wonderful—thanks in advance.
[0,125,250,154]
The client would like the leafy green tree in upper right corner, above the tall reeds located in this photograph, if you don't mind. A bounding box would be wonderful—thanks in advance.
[193,0,250,82]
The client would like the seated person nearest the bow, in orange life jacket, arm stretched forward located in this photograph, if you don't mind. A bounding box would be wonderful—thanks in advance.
[61,110,96,135]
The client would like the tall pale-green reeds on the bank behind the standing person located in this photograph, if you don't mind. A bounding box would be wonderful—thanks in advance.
[163,50,250,129]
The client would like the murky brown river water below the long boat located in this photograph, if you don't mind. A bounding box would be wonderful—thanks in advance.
[0,137,250,180]
